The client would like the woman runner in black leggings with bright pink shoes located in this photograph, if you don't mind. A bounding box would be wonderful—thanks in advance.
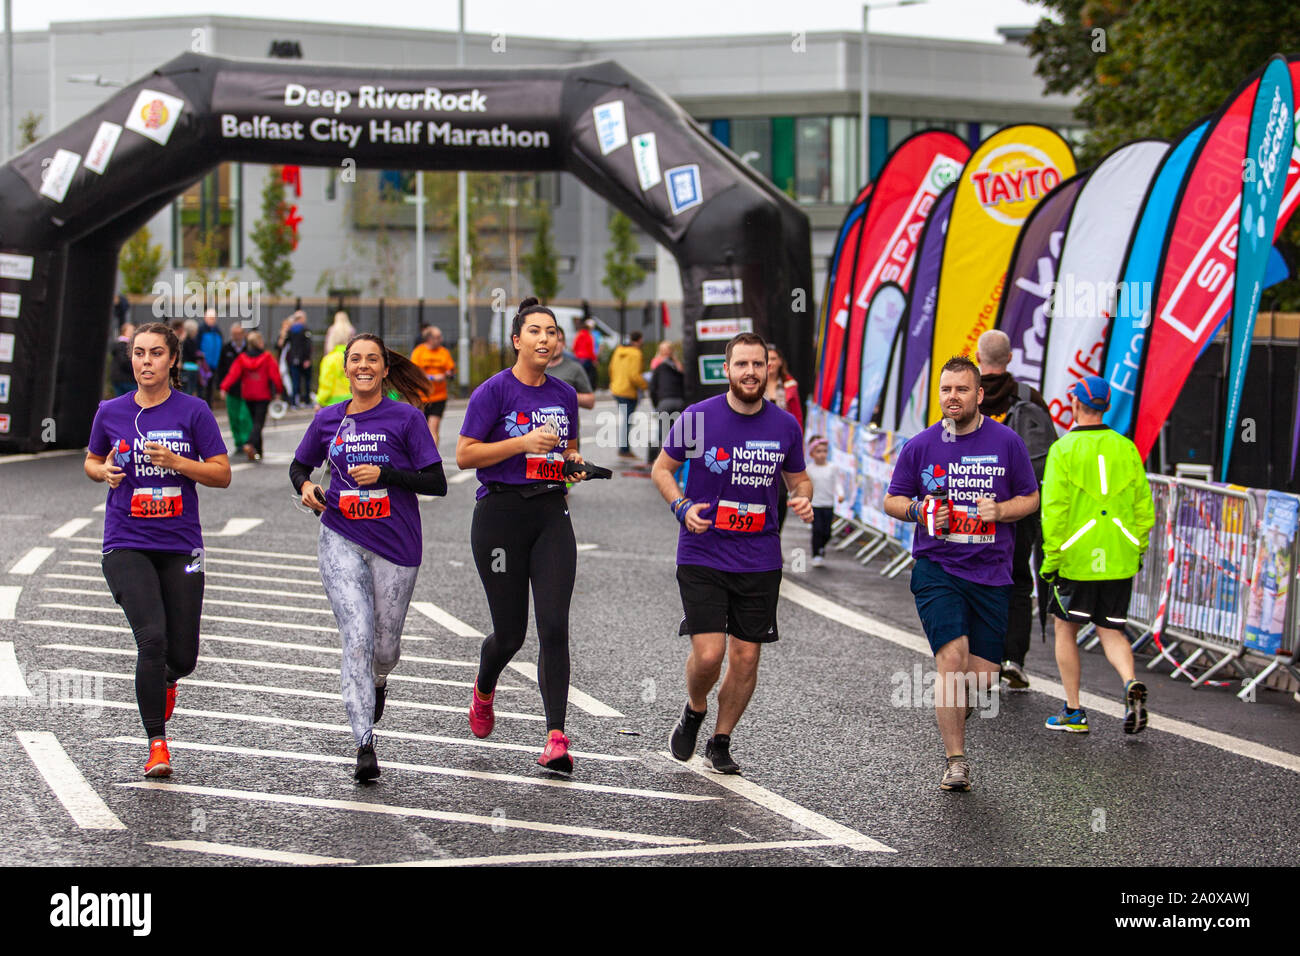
[456,298,586,774]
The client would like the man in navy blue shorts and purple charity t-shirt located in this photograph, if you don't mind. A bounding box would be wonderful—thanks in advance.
[884,356,1039,791]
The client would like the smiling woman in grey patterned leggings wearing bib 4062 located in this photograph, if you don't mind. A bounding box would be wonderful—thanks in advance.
[289,333,447,782]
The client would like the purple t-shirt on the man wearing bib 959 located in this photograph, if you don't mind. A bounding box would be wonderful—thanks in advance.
[663,393,806,571]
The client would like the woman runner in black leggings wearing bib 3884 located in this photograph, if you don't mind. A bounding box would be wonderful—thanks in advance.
[83,323,230,777]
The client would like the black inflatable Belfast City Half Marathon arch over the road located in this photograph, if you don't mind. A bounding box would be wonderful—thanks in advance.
[0,53,814,451]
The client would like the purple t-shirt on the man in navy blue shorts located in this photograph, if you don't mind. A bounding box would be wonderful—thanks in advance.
[889,416,1039,585]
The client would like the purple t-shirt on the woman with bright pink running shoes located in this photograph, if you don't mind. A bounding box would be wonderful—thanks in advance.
[460,368,577,498]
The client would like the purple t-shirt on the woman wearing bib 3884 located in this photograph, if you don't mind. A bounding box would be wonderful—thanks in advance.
[87,389,226,554]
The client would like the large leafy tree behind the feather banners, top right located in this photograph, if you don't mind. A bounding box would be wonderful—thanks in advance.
[1024,0,1300,304]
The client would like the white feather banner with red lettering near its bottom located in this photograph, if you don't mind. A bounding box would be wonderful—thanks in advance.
[1043,139,1169,434]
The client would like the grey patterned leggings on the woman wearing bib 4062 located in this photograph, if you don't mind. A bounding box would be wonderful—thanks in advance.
[317,524,420,747]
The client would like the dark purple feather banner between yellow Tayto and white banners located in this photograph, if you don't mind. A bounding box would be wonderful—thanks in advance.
[996,172,1088,389]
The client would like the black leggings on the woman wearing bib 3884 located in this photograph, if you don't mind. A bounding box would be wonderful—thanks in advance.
[104,548,203,737]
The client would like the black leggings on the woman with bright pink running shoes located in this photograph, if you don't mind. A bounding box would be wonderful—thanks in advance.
[469,492,577,731]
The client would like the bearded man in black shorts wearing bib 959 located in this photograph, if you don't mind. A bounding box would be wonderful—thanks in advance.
[651,332,813,774]
